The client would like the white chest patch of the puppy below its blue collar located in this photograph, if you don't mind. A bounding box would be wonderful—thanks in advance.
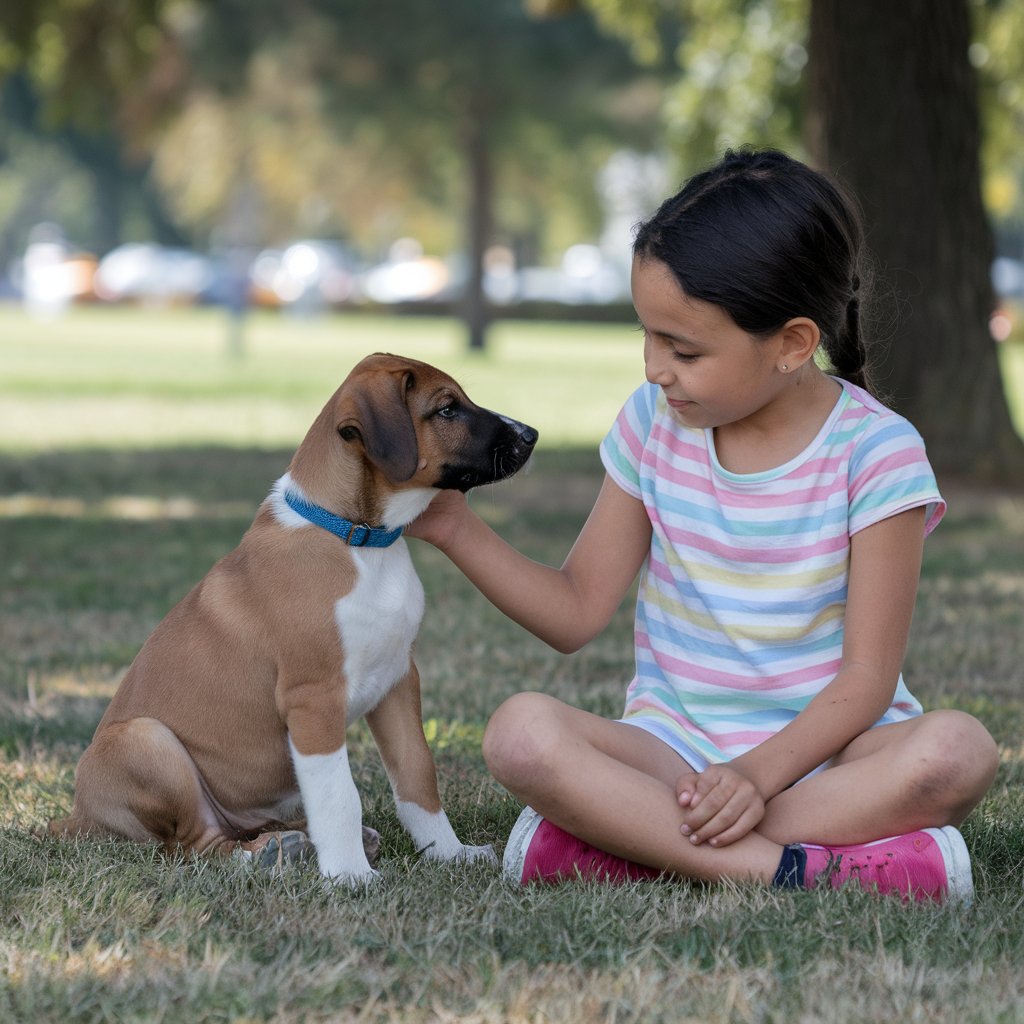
[334,540,423,721]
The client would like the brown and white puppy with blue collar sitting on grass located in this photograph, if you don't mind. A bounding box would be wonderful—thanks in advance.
[50,353,537,881]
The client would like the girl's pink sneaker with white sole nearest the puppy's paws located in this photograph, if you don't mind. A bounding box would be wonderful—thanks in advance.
[502,807,664,885]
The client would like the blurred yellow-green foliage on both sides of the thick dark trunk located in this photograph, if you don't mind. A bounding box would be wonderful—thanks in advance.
[584,0,1024,222]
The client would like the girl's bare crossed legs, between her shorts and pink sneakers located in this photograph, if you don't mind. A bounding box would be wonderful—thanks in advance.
[483,693,996,888]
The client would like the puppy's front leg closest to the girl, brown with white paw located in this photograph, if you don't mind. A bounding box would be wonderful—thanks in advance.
[367,666,498,862]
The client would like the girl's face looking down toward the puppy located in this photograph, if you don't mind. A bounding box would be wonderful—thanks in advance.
[632,256,782,428]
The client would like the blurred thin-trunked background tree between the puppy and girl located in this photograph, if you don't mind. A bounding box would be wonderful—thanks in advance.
[286,0,659,348]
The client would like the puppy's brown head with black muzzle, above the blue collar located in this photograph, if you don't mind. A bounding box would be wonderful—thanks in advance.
[293,352,538,524]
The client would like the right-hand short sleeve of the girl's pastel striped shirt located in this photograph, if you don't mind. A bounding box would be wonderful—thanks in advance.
[849,413,946,537]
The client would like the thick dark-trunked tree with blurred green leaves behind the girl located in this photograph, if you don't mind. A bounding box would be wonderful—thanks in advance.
[587,0,1024,479]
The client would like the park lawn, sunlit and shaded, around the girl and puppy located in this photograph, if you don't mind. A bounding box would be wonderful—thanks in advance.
[0,309,1024,1024]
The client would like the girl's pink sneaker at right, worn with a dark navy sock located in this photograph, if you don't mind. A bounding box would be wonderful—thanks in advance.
[801,825,974,905]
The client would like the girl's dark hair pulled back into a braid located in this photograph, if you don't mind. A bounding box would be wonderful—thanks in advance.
[633,148,870,390]
